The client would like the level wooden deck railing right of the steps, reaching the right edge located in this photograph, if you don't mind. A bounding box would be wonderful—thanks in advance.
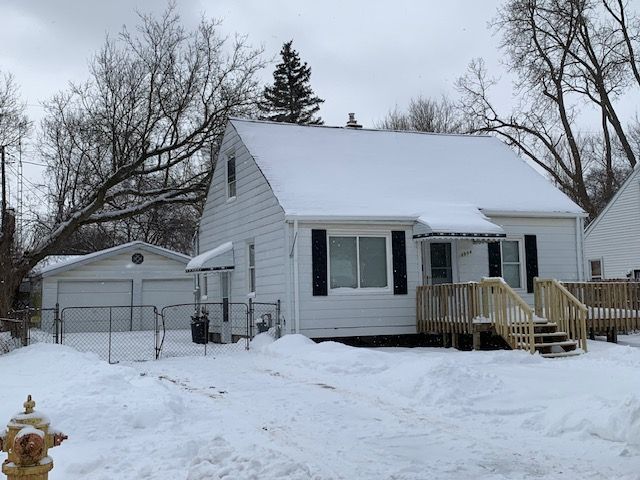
[562,281,640,334]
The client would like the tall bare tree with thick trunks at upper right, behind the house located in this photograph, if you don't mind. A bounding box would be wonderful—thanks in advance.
[457,0,639,218]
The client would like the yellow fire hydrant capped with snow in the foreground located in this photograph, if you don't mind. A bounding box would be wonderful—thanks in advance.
[0,395,67,480]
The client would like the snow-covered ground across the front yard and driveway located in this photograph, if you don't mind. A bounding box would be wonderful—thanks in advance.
[0,335,640,480]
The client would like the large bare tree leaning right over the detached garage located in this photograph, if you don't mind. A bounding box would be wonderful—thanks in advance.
[0,7,263,314]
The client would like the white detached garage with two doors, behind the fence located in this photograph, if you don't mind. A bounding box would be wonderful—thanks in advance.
[38,242,194,320]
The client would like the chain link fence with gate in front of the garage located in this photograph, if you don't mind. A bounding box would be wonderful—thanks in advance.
[0,300,282,363]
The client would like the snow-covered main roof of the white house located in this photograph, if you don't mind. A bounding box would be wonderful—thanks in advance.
[231,119,584,230]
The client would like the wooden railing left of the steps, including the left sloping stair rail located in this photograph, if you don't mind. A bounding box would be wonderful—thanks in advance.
[417,278,535,352]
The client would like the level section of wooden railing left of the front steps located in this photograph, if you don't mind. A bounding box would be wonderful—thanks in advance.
[417,282,480,333]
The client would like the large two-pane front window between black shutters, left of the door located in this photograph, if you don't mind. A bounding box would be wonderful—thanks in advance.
[328,235,389,289]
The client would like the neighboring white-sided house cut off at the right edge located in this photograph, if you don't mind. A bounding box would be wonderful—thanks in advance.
[584,168,640,280]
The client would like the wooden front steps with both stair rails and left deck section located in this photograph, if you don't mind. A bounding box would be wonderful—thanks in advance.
[417,278,588,357]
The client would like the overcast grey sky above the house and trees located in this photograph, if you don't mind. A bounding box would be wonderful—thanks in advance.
[0,0,511,199]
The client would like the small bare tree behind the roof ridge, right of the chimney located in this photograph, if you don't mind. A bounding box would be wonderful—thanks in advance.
[377,96,471,133]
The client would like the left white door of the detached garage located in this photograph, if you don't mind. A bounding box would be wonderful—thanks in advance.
[58,280,132,333]
